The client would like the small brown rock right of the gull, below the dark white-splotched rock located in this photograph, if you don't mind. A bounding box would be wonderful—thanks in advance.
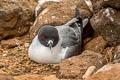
[85,36,107,53]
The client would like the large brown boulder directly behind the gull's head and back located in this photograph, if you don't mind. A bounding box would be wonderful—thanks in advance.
[30,0,92,39]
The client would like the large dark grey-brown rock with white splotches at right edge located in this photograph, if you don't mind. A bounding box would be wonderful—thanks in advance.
[91,8,120,45]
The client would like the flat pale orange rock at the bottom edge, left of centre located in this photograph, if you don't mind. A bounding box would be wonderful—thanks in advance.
[14,74,42,80]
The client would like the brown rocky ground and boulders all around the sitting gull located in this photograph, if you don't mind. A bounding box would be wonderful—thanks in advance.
[0,0,120,80]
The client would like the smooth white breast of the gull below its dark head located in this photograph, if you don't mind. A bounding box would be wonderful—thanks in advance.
[28,35,62,63]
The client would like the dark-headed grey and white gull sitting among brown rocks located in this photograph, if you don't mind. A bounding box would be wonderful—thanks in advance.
[28,9,88,64]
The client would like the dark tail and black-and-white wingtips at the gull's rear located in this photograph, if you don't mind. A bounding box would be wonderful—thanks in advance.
[66,8,88,49]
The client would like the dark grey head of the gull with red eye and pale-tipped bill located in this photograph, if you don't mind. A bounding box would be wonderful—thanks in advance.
[38,26,59,53]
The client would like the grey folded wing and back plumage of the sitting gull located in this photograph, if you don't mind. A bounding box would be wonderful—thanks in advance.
[56,17,88,58]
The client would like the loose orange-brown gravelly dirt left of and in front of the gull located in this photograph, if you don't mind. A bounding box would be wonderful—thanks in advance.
[0,35,56,75]
